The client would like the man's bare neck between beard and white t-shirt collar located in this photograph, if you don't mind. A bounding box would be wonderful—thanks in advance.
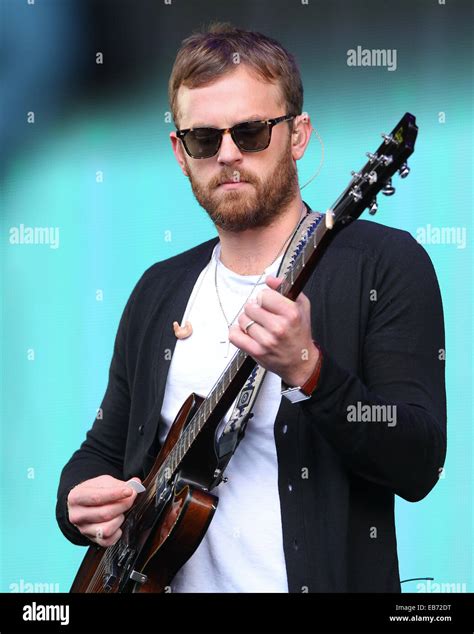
[217,193,306,275]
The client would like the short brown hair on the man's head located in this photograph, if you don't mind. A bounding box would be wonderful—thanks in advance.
[168,22,303,126]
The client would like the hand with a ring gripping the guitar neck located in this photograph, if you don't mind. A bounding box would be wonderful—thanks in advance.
[229,275,319,385]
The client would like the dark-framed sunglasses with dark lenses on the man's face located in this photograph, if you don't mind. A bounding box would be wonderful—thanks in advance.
[176,114,296,158]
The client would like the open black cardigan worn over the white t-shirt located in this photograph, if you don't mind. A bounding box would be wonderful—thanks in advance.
[57,210,446,592]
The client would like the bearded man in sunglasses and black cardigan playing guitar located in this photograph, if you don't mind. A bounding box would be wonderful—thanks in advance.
[57,25,446,592]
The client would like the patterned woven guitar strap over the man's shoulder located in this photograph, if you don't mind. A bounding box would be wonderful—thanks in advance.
[214,211,324,486]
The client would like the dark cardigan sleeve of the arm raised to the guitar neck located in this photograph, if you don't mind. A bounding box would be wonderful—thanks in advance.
[299,232,446,502]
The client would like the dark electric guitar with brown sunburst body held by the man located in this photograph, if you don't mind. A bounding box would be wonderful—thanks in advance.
[70,113,418,593]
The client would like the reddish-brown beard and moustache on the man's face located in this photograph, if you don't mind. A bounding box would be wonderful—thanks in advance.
[186,137,298,232]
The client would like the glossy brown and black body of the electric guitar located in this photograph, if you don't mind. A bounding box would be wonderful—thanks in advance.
[70,394,218,593]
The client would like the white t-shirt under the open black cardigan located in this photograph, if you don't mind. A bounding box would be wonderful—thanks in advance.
[158,243,288,592]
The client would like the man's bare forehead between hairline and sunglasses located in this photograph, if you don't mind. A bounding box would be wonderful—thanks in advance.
[177,65,286,129]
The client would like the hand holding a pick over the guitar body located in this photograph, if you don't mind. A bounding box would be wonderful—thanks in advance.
[67,475,141,547]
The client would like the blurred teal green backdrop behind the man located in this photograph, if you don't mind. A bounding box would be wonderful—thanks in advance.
[0,0,474,592]
